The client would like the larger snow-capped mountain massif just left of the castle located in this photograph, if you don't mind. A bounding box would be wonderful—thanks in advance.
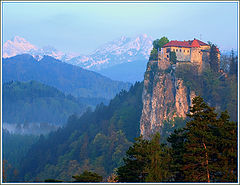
[67,34,153,71]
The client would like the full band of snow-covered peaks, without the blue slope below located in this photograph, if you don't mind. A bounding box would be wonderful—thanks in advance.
[3,34,153,75]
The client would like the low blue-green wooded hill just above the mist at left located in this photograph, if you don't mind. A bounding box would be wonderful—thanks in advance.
[3,81,86,125]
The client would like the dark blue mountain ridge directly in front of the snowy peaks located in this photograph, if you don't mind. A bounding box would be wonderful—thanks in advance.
[2,54,131,99]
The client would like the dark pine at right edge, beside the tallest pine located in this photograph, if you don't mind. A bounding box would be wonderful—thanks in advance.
[215,111,237,182]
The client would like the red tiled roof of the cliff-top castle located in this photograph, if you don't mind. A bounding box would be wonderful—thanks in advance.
[163,39,208,48]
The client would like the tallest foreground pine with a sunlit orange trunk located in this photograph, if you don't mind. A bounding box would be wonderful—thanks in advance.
[183,97,217,182]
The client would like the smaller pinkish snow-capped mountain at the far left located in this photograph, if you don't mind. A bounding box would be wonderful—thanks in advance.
[3,36,77,61]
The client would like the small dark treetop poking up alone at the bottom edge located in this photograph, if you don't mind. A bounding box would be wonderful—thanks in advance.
[72,170,103,182]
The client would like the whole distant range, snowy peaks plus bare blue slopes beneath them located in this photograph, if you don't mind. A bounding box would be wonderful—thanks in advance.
[3,34,153,82]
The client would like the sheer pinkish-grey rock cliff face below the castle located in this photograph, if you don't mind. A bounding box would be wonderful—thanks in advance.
[140,60,195,138]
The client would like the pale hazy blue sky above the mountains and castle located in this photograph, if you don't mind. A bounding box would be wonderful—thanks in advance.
[2,2,238,54]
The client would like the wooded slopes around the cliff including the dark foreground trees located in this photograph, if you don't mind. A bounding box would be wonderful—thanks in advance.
[4,47,237,182]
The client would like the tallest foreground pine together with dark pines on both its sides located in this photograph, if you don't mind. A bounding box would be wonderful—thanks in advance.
[169,97,237,182]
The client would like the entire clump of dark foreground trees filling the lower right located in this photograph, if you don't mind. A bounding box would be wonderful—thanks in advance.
[117,96,237,182]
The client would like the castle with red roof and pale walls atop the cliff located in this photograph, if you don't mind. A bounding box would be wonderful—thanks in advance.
[158,38,220,73]
